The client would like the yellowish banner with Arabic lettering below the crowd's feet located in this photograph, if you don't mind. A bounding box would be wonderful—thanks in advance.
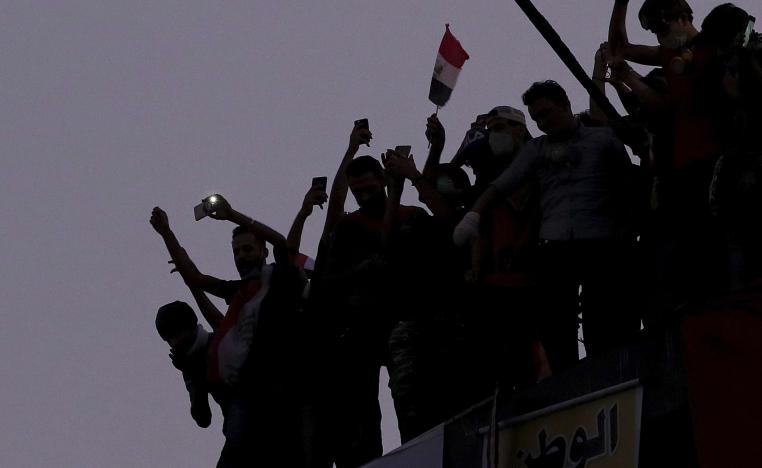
[482,381,642,468]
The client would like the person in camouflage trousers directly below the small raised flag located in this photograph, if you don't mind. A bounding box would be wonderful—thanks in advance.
[384,123,484,436]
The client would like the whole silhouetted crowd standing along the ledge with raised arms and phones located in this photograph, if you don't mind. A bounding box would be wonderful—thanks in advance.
[145,0,762,468]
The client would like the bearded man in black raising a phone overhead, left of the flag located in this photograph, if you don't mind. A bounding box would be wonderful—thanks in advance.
[318,135,424,468]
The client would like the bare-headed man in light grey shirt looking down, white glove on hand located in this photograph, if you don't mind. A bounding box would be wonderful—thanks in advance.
[454,81,639,372]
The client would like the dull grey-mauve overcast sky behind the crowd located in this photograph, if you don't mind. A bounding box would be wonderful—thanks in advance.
[0,0,760,468]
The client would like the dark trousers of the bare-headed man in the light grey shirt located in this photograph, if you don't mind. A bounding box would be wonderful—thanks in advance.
[539,240,640,372]
